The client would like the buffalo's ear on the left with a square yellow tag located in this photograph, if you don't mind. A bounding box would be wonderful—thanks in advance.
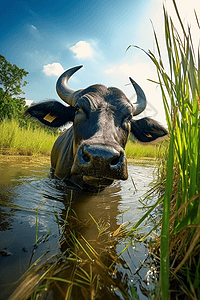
[25,100,74,128]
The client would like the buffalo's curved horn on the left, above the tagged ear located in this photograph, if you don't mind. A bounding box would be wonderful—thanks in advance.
[56,66,82,106]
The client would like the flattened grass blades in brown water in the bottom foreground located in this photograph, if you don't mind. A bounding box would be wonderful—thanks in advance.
[9,207,144,300]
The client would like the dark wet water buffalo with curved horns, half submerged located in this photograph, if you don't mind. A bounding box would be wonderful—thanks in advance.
[26,66,167,191]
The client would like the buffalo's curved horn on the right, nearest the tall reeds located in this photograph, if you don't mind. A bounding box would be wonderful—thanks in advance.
[129,77,147,116]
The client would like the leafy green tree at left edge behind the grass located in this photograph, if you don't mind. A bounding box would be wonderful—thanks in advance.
[0,55,28,119]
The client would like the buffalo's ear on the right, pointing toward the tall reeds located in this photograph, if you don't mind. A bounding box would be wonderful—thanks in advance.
[131,118,168,143]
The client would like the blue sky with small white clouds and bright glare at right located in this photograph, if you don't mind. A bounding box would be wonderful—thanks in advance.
[0,0,200,125]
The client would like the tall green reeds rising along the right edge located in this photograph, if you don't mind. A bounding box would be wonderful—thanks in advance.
[136,0,200,300]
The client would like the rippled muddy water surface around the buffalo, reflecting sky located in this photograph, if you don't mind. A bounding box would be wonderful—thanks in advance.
[0,160,159,300]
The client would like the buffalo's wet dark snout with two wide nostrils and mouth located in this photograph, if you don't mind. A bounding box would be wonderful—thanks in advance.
[72,144,128,180]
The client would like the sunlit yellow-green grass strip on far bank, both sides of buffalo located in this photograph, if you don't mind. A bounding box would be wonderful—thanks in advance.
[0,119,161,159]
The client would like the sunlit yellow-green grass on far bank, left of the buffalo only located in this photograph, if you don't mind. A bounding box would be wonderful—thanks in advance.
[0,119,59,155]
